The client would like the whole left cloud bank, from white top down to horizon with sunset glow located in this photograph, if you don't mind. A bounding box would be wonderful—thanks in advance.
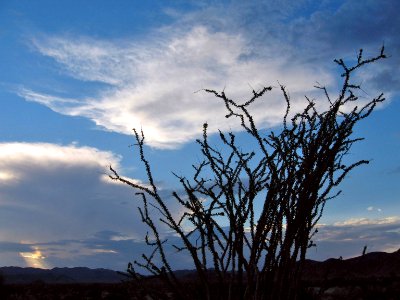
[0,143,194,270]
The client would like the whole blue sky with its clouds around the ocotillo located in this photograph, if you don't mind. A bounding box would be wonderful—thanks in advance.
[0,0,400,270]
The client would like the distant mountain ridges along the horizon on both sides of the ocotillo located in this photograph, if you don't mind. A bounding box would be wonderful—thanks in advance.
[0,249,400,284]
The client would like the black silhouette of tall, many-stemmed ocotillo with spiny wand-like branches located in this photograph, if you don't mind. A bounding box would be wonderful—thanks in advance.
[110,47,386,300]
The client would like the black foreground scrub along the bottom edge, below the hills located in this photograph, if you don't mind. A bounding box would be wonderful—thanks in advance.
[0,277,400,300]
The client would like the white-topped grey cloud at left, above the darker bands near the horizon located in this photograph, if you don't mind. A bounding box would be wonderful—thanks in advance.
[0,143,133,237]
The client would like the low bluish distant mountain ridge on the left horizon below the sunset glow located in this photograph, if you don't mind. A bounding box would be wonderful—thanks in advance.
[0,267,126,284]
